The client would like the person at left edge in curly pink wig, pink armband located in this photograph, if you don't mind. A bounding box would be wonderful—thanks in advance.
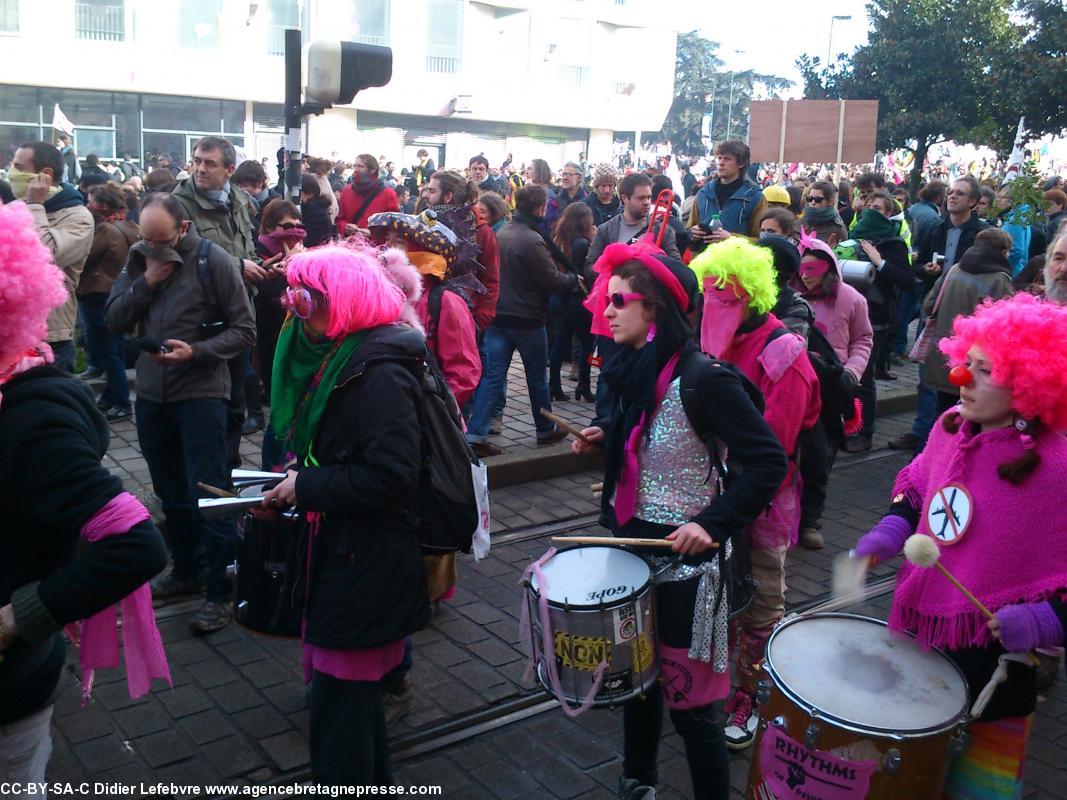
[0,203,170,798]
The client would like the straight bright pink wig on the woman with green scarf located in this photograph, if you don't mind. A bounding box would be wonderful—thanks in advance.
[285,237,405,339]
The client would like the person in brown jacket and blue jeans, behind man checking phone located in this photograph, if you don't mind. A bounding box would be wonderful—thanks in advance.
[78,185,141,421]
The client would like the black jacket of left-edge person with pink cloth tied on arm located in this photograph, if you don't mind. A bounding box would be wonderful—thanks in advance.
[0,366,166,725]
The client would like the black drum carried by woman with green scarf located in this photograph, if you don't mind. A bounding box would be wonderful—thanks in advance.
[234,485,306,637]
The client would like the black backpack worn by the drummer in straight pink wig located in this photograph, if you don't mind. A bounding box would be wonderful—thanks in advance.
[368,350,480,556]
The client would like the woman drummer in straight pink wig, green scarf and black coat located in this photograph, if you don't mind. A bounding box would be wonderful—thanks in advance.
[253,243,430,786]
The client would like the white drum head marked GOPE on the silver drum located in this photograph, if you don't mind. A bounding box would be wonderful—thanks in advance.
[530,545,652,608]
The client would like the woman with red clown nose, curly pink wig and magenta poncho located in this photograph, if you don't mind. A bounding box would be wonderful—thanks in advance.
[856,294,1067,800]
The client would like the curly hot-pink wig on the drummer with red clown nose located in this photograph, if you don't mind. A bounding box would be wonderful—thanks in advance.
[939,294,1067,431]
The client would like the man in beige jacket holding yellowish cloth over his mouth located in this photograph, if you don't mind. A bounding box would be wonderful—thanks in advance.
[7,142,93,372]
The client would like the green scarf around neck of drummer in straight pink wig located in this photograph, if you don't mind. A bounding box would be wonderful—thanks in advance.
[270,315,365,463]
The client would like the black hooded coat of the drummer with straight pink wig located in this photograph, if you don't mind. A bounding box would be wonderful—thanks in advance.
[297,325,430,650]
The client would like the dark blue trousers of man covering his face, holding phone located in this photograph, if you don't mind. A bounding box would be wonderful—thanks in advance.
[137,398,237,603]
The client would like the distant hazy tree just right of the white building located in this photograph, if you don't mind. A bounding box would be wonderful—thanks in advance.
[653,31,793,155]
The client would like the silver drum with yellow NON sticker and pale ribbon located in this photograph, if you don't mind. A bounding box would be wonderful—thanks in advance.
[526,545,659,707]
